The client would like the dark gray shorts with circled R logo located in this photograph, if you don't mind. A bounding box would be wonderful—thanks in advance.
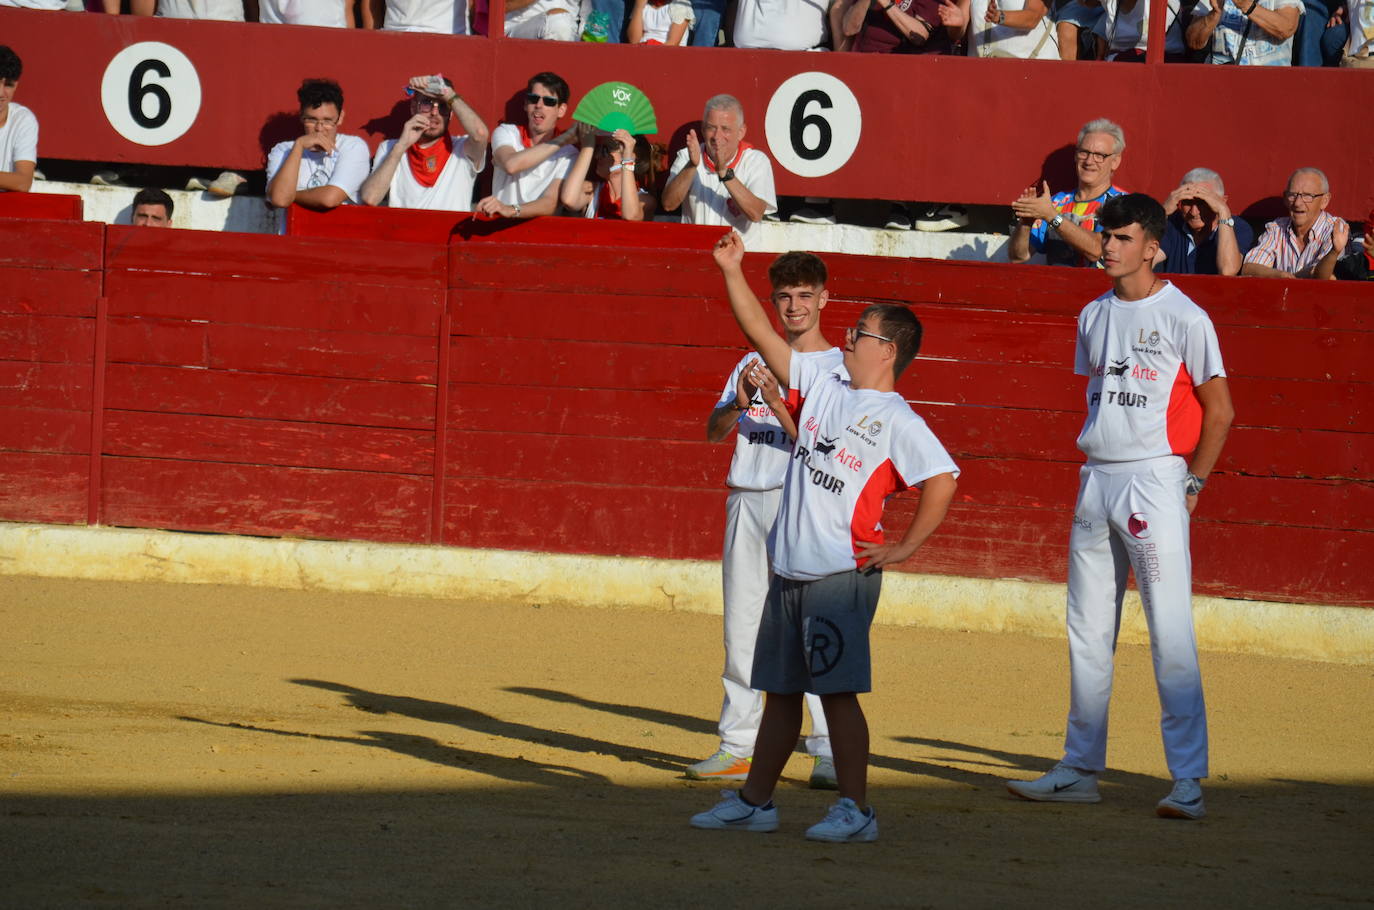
[750,570,882,696]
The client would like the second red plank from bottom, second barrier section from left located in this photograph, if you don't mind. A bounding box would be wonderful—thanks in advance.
[104,410,434,474]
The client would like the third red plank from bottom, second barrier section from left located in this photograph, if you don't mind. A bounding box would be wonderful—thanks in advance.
[102,363,434,429]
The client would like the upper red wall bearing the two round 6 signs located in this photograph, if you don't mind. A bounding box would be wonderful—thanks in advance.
[0,10,1374,220]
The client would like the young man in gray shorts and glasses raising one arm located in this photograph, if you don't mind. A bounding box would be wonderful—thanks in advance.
[691,232,958,843]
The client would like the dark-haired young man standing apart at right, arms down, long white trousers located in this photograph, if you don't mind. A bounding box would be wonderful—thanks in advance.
[1007,194,1235,818]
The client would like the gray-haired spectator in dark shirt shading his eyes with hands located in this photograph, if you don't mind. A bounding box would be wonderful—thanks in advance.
[1154,168,1254,275]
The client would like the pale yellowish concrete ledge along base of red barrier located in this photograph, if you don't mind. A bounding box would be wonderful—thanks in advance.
[0,522,1374,664]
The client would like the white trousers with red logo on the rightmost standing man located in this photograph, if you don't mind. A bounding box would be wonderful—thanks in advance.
[1063,455,1208,779]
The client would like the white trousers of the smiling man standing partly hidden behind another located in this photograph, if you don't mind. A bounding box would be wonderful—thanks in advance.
[720,489,830,757]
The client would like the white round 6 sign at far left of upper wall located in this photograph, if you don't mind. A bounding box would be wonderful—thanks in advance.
[100,41,201,146]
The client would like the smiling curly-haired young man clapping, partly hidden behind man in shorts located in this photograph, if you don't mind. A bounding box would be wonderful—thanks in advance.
[687,253,844,789]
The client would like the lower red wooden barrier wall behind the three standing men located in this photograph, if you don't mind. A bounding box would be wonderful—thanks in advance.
[0,209,1374,606]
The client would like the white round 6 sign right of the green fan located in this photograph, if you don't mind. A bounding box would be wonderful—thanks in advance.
[764,73,863,177]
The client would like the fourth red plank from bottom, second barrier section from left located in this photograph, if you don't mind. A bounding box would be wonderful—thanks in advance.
[110,316,438,384]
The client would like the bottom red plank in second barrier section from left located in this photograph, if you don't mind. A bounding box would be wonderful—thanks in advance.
[102,456,430,543]
